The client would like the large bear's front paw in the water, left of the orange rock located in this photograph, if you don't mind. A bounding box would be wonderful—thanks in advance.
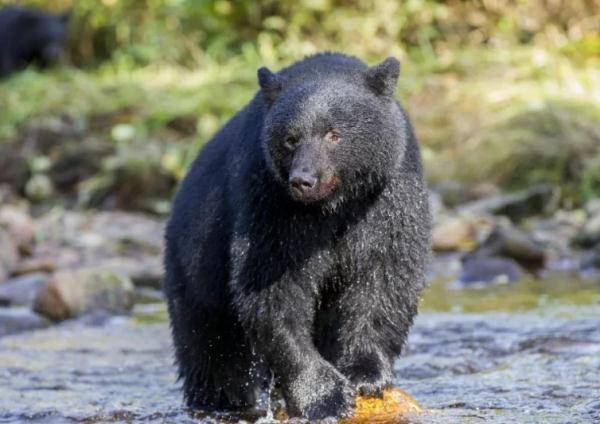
[287,364,356,420]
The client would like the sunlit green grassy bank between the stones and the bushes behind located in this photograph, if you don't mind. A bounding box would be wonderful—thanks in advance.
[0,46,600,204]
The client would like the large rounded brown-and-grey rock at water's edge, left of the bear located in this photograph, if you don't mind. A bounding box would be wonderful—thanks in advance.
[34,269,134,321]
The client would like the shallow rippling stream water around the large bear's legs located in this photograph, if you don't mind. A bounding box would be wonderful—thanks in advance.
[0,281,600,424]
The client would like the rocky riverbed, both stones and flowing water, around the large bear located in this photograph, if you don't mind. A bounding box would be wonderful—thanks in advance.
[0,186,600,423]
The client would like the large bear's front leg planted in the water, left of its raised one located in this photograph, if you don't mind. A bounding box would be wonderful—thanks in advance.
[235,281,355,420]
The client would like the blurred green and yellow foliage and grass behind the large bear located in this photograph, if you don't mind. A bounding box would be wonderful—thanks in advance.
[0,0,600,212]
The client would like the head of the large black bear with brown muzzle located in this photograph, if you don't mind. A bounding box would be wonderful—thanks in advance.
[258,58,406,205]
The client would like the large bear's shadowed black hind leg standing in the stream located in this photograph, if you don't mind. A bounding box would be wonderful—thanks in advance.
[165,261,261,410]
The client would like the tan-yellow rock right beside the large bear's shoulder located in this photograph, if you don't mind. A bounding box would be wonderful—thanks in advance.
[432,216,492,252]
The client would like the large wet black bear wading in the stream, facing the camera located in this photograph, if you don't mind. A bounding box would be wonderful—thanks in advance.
[165,53,430,419]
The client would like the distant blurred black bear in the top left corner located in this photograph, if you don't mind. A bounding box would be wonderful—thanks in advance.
[0,6,69,77]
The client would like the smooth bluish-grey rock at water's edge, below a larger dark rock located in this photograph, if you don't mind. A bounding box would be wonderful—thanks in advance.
[456,257,523,287]
